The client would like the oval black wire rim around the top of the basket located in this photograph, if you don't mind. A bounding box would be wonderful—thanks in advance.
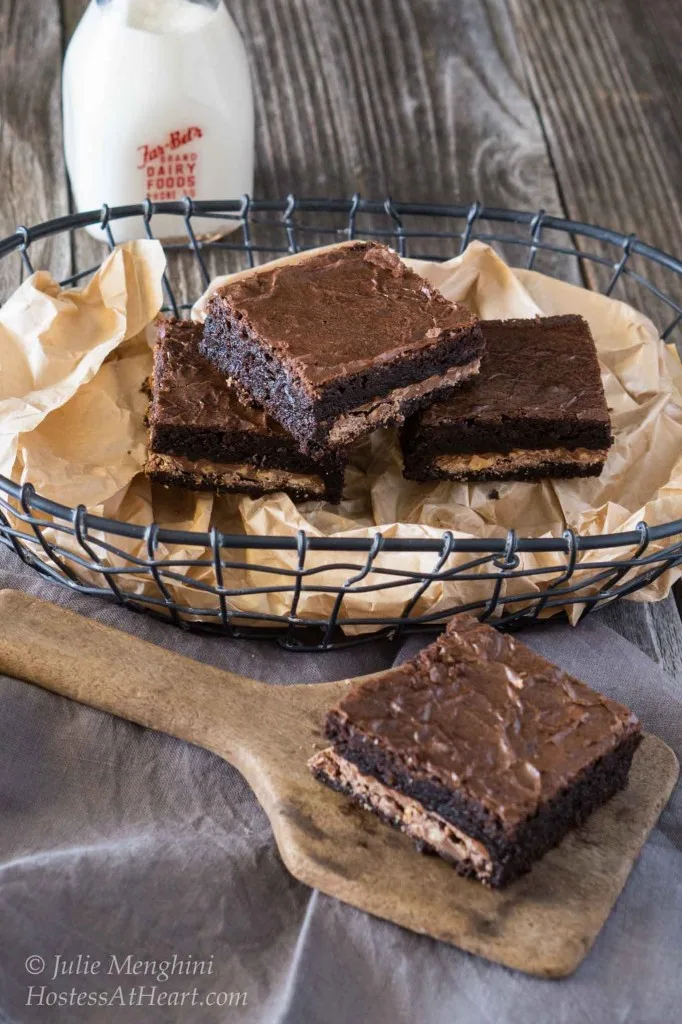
[0,194,682,557]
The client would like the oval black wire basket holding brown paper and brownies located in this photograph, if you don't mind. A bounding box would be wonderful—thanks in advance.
[0,196,682,650]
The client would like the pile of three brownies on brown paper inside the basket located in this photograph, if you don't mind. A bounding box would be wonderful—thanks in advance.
[146,241,611,503]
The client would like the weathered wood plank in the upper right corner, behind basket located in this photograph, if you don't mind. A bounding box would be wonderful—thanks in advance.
[511,0,682,335]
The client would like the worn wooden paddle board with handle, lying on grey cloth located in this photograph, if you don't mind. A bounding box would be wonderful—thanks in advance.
[0,591,678,978]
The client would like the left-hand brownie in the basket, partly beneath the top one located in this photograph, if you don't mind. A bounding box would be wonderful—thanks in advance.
[146,319,344,502]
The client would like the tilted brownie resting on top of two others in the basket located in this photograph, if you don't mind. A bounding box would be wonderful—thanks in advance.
[201,242,482,458]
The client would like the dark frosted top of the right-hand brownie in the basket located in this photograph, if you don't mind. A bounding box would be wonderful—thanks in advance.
[420,314,609,427]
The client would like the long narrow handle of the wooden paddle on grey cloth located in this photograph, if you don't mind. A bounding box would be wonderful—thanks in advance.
[0,590,279,766]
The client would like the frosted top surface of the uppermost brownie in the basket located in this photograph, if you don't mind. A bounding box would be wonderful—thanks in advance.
[212,242,477,384]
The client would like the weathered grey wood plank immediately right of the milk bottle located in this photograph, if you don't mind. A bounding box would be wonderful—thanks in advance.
[229,0,574,272]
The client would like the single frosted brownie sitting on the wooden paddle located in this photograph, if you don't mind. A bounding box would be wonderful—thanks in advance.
[309,614,640,888]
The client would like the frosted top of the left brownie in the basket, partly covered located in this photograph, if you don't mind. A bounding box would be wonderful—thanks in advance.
[150,319,288,437]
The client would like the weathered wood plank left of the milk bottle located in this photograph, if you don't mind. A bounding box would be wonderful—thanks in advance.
[0,0,71,300]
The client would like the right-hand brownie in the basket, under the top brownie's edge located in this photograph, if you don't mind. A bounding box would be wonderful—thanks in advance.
[401,315,612,480]
